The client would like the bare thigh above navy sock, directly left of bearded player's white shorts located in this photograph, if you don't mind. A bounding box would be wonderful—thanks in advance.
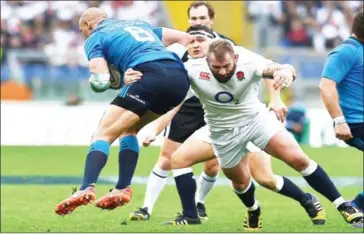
[171,136,215,169]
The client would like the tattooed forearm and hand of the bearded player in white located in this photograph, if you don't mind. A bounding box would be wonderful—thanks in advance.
[262,63,297,89]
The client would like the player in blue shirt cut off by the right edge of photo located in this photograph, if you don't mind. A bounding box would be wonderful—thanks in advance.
[319,10,364,227]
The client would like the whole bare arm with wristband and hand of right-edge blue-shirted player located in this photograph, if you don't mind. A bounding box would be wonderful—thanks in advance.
[319,77,353,140]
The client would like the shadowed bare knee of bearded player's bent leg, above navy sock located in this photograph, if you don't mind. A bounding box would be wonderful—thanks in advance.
[221,156,251,187]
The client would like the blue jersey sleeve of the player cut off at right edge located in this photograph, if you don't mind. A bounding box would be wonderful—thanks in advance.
[321,45,357,83]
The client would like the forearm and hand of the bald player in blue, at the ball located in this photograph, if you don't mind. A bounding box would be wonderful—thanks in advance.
[89,58,110,92]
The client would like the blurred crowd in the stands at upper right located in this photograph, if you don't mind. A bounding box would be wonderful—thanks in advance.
[246,1,363,52]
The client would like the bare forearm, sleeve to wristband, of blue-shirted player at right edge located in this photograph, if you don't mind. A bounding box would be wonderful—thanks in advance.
[319,82,343,119]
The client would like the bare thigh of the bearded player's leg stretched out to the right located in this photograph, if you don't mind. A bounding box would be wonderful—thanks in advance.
[265,130,310,171]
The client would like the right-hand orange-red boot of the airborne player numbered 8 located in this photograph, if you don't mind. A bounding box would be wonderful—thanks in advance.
[95,187,132,210]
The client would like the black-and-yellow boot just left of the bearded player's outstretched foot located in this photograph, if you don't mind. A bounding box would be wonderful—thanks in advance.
[301,193,326,225]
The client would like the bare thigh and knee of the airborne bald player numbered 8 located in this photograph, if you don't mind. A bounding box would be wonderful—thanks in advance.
[93,105,140,143]
